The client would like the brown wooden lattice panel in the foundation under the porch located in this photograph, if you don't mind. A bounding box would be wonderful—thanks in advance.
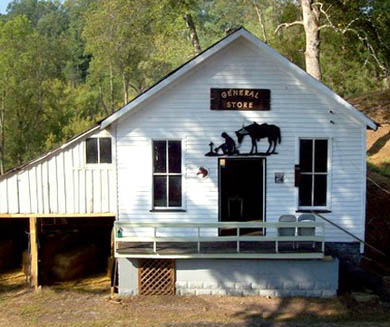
[138,259,175,295]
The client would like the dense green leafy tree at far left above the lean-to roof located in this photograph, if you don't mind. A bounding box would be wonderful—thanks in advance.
[0,16,78,171]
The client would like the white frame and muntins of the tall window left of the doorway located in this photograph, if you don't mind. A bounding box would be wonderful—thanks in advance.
[150,138,185,212]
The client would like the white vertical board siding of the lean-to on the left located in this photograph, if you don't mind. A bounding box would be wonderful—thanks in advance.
[0,130,116,214]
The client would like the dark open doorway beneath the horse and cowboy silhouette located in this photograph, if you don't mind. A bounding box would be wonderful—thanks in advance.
[219,158,265,235]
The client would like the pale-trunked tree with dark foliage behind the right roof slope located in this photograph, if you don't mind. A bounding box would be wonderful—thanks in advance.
[276,0,390,84]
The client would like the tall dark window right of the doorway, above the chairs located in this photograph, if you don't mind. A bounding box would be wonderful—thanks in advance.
[299,139,328,207]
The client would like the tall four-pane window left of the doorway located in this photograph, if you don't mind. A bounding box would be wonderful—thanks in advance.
[153,141,182,208]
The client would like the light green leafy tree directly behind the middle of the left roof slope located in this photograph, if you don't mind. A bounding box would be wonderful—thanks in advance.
[83,0,176,113]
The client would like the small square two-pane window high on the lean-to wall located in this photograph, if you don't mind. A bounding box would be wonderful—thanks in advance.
[85,137,112,164]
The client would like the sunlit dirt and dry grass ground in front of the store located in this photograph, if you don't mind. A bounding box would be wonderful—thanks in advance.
[0,272,390,327]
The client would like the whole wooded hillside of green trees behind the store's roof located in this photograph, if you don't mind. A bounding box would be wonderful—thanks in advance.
[0,0,390,173]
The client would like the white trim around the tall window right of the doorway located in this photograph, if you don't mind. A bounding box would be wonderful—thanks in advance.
[295,136,333,211]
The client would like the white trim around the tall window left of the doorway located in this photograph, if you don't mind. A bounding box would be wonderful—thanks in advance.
[150,137,186,212]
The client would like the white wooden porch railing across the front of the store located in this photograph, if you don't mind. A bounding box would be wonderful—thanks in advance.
[114,222,325,259]
